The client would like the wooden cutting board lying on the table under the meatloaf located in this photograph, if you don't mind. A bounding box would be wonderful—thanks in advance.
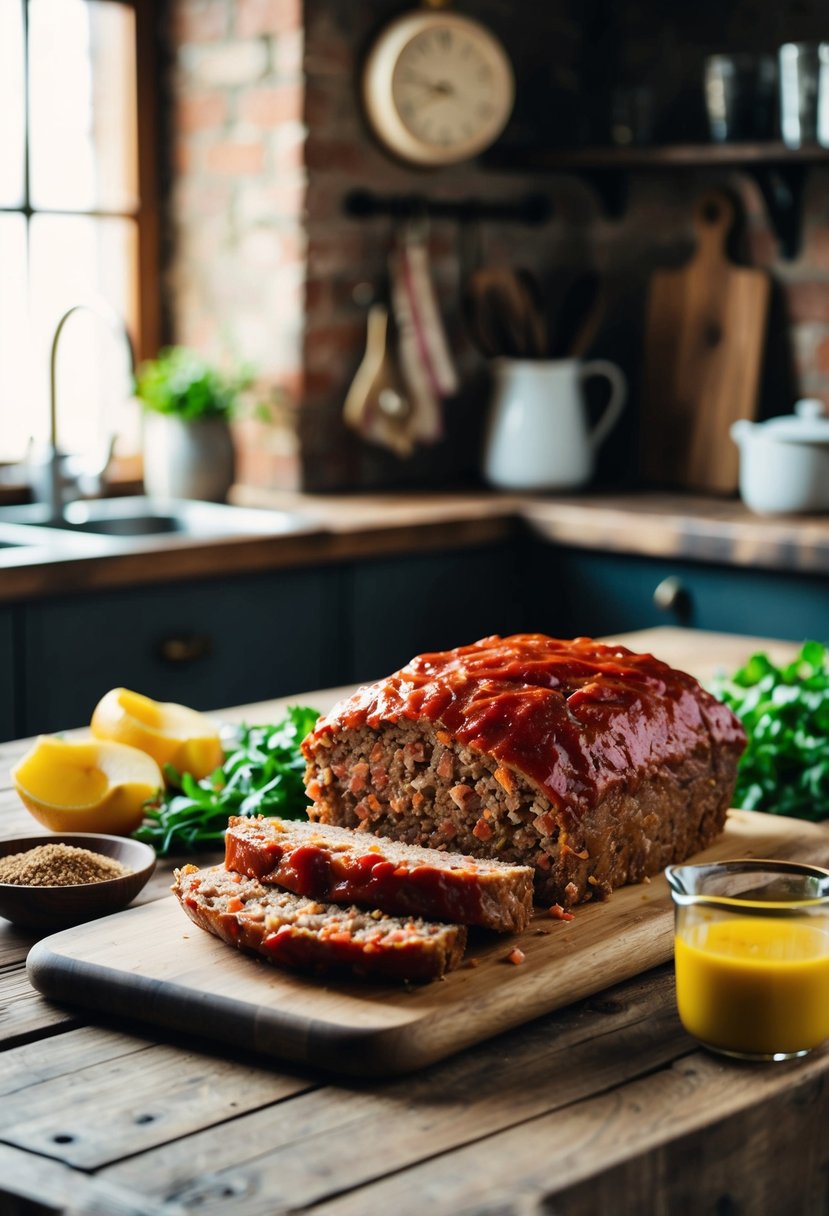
[28,811,829,1076]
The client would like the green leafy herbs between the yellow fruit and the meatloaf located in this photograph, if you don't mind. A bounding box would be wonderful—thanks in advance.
[134,705,318,855]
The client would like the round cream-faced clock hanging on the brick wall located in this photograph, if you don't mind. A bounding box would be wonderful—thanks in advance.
[362,6,515,167]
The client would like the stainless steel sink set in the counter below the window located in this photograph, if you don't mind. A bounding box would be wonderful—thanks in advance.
[0,497,318,542]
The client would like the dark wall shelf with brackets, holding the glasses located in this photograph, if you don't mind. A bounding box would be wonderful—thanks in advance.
[484,142,829,258]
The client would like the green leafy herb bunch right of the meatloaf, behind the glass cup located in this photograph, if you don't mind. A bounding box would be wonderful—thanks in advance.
[712,641,829,820]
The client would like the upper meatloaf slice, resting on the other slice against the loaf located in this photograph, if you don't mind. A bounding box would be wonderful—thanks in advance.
[225,817,532,933]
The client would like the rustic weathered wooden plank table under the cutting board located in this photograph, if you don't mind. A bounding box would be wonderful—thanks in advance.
[0,630,829,1216]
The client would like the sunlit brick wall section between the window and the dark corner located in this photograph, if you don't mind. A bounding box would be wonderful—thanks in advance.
[165,0,305,485]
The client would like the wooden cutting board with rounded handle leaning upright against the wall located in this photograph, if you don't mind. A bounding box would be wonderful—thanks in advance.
[639,192,769,494]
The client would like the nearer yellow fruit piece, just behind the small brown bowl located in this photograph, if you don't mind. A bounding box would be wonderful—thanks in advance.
[11,734,164,835]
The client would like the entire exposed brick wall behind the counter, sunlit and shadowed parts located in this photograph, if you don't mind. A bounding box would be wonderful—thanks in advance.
[169,0,829,489]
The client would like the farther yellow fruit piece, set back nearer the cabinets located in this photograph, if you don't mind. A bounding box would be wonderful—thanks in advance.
[91,688,225,781]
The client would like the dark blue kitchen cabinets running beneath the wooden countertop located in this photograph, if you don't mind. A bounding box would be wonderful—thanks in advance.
[11,535,829,739]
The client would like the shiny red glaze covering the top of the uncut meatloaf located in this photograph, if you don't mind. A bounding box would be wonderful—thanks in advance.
[303,634,745,816]
